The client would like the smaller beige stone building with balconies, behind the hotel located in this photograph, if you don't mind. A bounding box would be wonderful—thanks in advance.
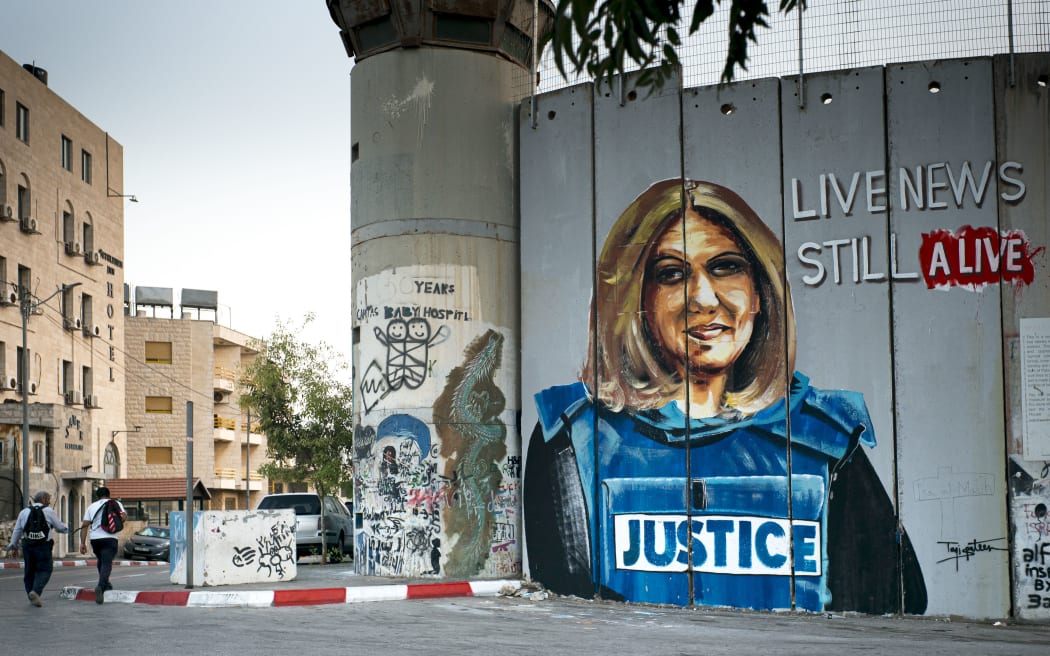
[120,287,267,516]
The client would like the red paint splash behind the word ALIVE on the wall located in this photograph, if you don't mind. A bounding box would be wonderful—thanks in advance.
[919,226,1046,291]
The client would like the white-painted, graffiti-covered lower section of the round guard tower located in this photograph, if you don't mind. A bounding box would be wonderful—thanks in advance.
[354,266,522,576]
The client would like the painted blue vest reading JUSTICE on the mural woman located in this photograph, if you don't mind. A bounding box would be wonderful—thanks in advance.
[536,374,875,611]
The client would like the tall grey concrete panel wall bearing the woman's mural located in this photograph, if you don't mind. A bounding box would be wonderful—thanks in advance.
[519,55,1050,621]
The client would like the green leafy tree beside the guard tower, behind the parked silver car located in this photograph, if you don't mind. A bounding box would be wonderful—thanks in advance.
[240,314,354,562]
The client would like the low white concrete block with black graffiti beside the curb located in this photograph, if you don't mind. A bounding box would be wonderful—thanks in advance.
[170,510,297,586]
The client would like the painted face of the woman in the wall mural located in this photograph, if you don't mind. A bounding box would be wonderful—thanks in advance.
[643,210,759,379]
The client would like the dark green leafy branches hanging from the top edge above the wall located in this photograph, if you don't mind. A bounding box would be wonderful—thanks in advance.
[546,0,805,89]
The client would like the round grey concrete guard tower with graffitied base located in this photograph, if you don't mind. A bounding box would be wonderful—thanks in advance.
[327,0,553,578]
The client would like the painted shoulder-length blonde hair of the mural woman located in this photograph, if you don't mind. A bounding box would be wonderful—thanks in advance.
[581,178,795,414]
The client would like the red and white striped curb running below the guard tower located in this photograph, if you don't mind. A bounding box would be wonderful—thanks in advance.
[62,580,522,608]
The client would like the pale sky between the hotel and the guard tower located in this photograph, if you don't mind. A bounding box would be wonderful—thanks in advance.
[0,0,353,358]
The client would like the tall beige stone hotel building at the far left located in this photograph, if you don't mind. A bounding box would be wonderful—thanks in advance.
[0,46,130,541]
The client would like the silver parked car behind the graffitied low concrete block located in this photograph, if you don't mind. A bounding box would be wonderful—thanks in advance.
[257,492,354,555]
